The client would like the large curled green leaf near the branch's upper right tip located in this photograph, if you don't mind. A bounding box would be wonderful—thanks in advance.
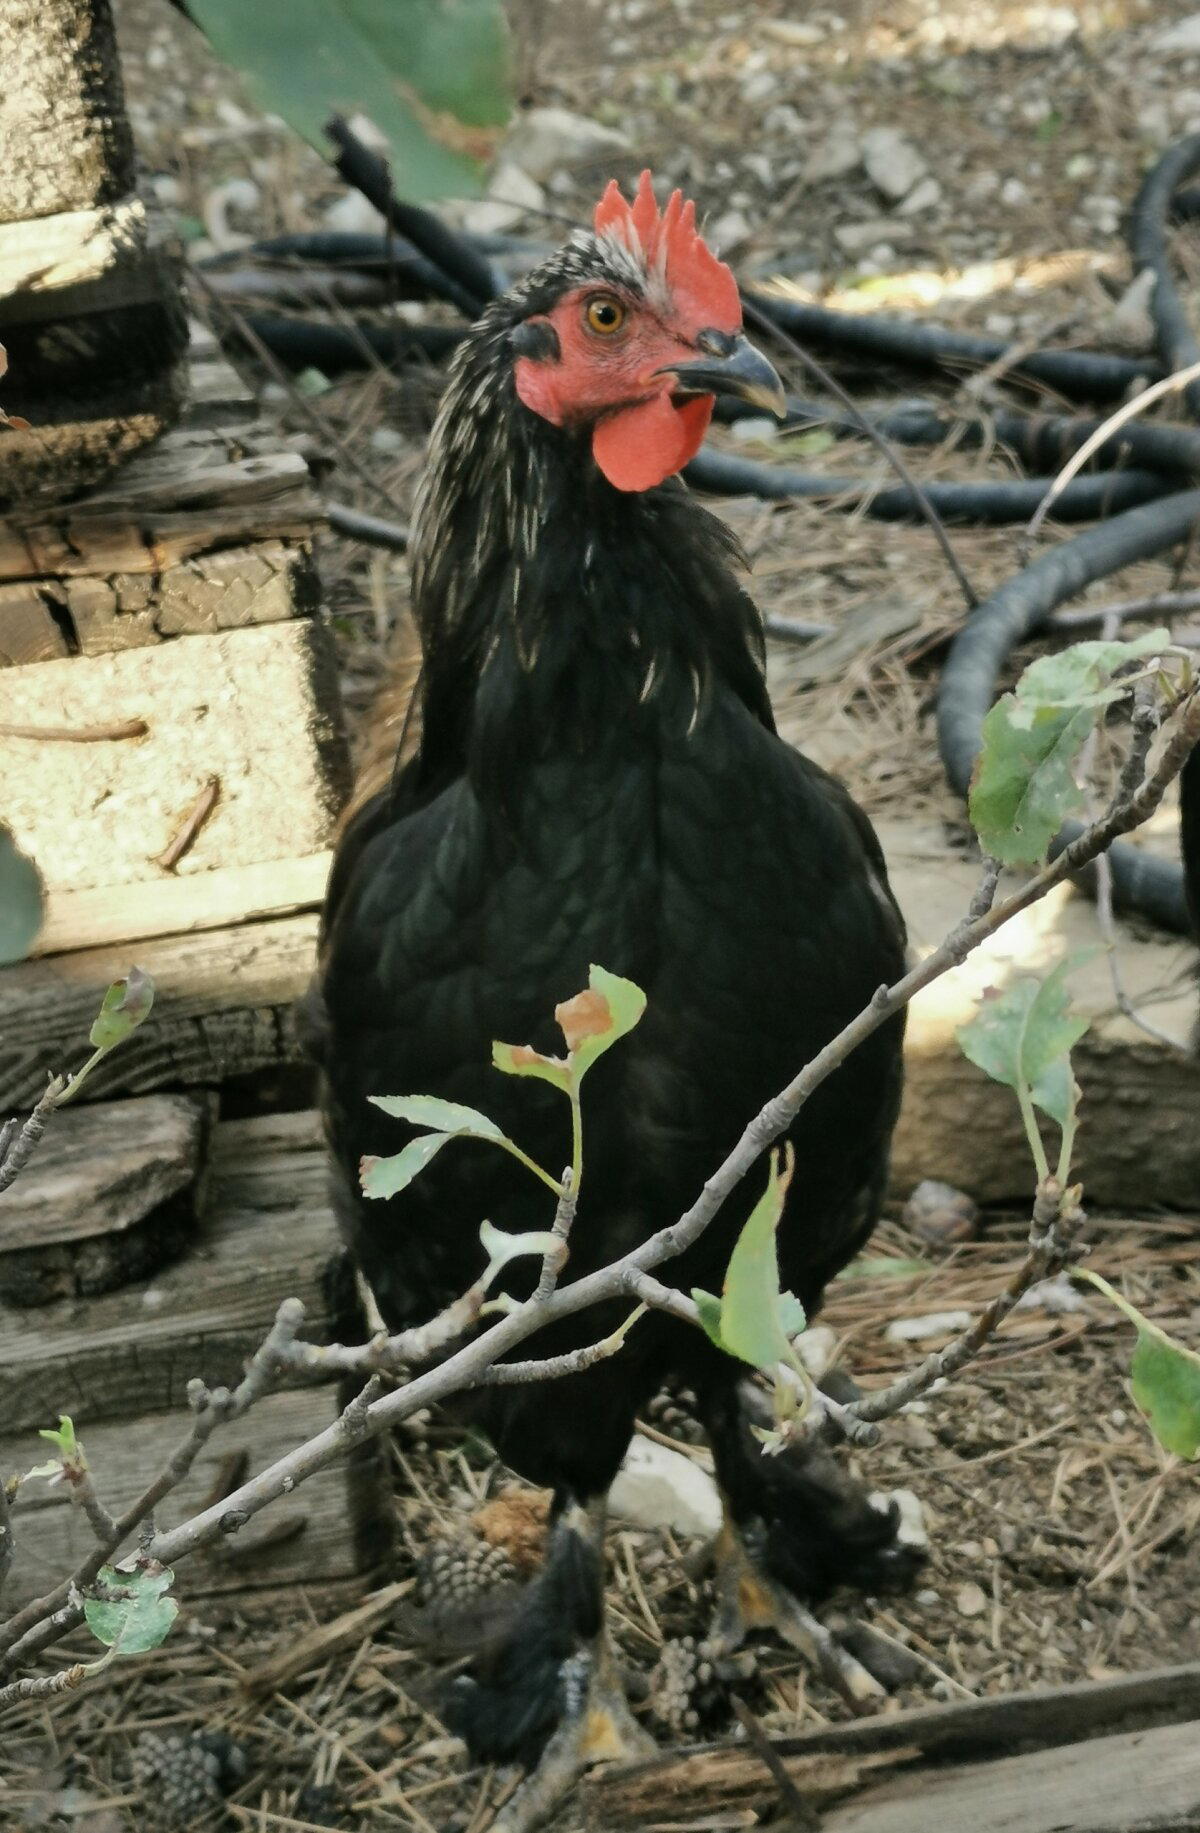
[969,631,1171,865]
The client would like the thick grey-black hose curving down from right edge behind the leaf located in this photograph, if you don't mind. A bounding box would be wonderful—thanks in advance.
[938,489,1200,935]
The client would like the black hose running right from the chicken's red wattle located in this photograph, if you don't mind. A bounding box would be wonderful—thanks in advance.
[683,449,1171,528]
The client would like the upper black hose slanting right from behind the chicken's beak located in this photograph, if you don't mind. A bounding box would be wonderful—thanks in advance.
[744,290,1162,401]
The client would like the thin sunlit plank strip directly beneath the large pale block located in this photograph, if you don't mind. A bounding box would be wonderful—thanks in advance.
[33,851,333,955]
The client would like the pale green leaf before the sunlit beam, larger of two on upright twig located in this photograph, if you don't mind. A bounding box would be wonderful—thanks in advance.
[958,957,1090,1127]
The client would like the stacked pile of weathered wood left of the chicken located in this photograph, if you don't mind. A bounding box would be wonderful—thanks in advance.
[0,0,388,1606]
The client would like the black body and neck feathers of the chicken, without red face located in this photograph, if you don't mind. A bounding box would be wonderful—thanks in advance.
[319,242,903,1498]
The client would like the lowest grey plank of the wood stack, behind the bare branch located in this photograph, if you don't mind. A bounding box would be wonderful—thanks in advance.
[0,1388,392,1609]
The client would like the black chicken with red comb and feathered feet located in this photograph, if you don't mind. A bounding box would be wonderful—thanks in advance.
[319,174,905,1829]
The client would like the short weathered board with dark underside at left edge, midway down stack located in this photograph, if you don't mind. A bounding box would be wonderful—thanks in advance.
[0,1094,216,1305]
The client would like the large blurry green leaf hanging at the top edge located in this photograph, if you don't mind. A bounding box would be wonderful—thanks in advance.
[191,0,511,198]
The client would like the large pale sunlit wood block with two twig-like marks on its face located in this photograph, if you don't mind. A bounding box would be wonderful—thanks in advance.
[0,620,348,923]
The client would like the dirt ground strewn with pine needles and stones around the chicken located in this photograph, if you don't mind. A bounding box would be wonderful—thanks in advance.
[0,0,1200,1833]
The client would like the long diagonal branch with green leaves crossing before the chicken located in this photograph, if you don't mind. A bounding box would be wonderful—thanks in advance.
[0,632,1200,1707]
